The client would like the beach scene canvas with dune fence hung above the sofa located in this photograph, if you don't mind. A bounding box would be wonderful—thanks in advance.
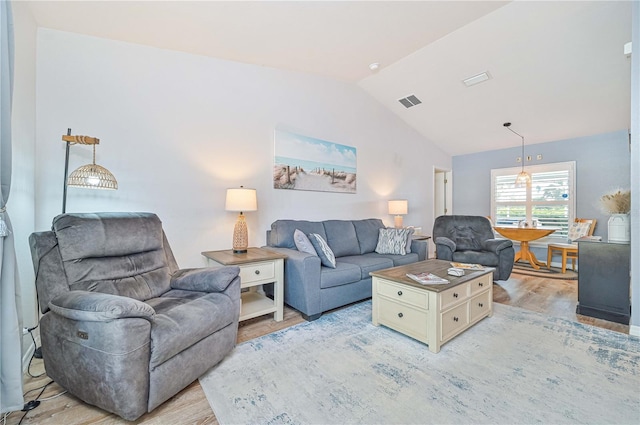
[273,130,356,193]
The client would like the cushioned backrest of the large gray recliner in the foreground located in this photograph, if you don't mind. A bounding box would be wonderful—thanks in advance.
[30,213,177,313]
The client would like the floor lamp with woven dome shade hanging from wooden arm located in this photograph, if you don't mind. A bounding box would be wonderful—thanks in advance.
[62,128,118,214]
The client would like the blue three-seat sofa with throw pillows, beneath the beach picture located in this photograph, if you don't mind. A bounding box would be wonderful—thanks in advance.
[267,218,427,321]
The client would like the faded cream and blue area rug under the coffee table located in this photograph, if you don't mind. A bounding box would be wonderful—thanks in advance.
[200,301,640,424]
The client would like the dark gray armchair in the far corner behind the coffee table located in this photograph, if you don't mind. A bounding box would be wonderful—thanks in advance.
[433,215,515,280]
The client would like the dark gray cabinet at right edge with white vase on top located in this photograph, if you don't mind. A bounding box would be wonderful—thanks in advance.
[576,241,631,325]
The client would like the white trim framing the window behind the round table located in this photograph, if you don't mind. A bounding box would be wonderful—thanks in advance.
[491,158,576,243]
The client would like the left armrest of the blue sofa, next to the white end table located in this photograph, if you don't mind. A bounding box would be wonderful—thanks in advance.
[265,246,322,316]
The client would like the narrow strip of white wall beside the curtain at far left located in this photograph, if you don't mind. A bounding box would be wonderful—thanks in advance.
[7,2,38,358]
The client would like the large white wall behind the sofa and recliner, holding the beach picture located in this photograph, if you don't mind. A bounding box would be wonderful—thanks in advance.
[30,29,451,267]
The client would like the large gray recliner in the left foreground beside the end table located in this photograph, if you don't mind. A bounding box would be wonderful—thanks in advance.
[29,213,240,420]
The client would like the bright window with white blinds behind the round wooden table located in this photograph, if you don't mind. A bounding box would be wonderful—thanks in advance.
[491,161,576,238]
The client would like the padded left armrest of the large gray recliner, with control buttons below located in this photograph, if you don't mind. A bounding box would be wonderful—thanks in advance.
[49,291,156,322]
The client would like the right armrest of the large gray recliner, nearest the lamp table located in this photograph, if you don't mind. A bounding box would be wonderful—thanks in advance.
[171,266,240,292]
